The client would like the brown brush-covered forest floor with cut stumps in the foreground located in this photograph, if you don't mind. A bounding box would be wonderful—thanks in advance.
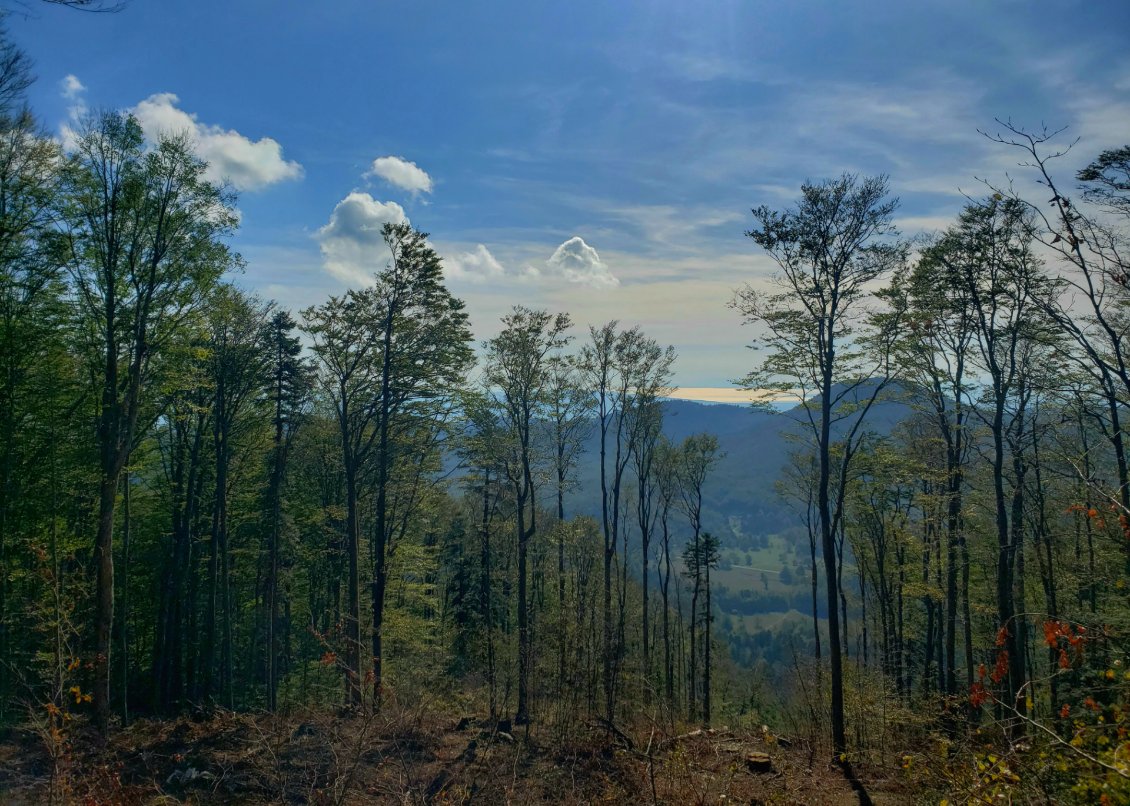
[0,711,910,806]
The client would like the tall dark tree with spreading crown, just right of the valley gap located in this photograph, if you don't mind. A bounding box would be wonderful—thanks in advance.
[732,174,904,759]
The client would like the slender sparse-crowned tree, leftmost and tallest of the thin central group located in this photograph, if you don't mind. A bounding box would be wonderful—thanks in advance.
[483,306,572,725]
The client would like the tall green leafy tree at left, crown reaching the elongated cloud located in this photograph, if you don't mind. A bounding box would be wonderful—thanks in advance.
[66,113,236,731]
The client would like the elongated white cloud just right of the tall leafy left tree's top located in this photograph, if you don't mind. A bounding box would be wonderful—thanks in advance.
[131,93,303,190]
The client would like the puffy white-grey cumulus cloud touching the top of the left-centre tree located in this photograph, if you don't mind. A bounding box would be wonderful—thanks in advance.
[316,191,409,285]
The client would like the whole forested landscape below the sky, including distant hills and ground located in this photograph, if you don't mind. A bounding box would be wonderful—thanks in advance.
[0,11,1130,804]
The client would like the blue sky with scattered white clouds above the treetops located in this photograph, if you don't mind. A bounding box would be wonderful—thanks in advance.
[8,0,1130,397]
